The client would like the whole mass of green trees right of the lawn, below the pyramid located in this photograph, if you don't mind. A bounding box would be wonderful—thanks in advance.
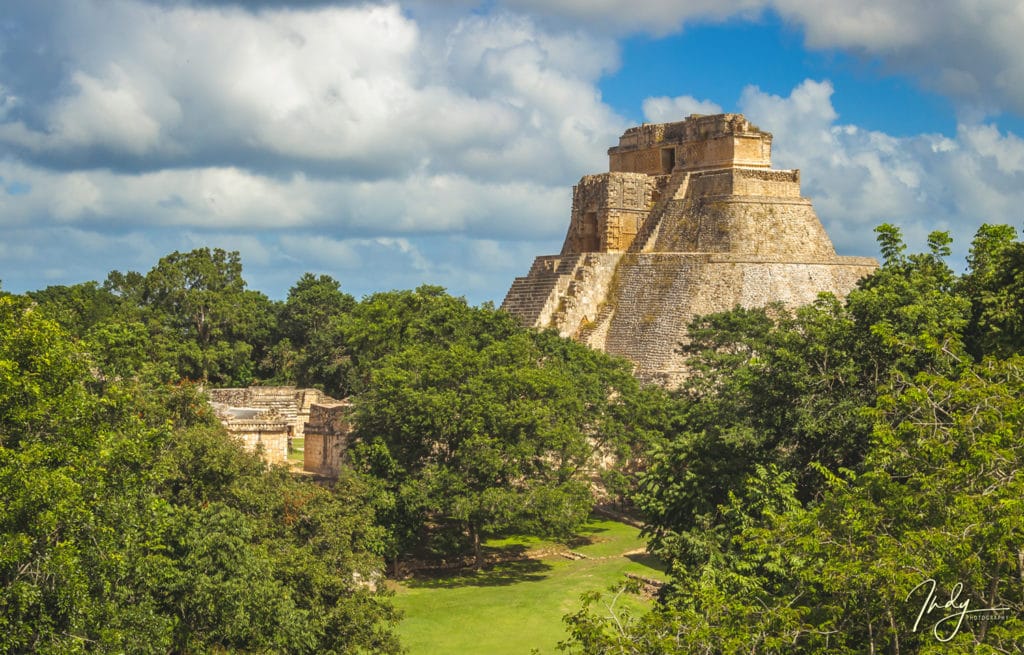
[564,226,1024,655]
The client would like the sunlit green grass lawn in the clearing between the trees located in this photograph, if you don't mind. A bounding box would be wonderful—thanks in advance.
[394,519,665,655]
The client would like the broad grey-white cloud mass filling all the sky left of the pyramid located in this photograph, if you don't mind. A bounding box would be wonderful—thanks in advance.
[0,0,626,300]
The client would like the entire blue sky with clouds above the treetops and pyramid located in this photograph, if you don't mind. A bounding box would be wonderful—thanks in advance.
[0,0,1024,303]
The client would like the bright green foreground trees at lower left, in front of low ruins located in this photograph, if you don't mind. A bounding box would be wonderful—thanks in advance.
[0,297,399,653]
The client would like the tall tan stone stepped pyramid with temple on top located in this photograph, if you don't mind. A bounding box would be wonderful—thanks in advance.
[502,114,878,386]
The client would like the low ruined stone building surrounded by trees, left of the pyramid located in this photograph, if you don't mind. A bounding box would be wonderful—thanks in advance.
[208,387,351,478]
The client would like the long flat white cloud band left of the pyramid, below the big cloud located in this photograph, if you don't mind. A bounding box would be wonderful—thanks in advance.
[0,155,569,239]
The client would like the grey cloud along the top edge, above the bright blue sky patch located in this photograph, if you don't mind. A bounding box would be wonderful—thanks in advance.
[503,0,1024,117]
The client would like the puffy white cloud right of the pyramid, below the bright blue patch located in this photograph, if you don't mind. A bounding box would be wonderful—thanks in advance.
[739,80,1024,261]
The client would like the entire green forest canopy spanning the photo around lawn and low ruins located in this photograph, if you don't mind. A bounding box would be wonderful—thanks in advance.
[8,225,1024,655]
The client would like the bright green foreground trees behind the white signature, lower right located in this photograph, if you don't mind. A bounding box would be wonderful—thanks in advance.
[563,355,1024,655]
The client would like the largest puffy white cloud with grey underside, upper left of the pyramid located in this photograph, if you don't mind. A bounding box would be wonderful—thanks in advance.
[0,0,622,180]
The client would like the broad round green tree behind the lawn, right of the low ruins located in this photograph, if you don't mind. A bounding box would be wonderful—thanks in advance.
[348,290,635,564]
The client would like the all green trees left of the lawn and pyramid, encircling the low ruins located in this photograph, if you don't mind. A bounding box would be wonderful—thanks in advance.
[0,249,641,653]
